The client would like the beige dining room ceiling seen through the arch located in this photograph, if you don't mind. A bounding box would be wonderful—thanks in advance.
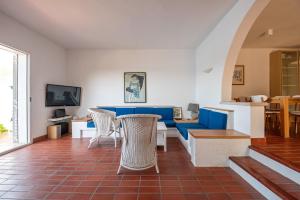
[243,0,300,48]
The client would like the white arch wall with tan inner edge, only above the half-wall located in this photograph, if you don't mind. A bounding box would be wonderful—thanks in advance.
[196,0,270,106]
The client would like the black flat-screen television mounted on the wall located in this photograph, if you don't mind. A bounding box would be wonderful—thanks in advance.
[46,84,81,107]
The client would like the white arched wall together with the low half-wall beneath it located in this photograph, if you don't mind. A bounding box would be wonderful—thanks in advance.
[195,0,270,138]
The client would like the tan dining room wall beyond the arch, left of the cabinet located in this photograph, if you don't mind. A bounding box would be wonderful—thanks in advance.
[232,48,274,98]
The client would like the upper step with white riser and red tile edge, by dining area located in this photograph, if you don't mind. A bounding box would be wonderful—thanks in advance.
[249,145,300,184]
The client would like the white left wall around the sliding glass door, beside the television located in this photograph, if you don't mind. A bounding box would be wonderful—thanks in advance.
[0,13,66,138]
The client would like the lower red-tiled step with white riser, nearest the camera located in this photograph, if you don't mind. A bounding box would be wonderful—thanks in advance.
[229,156,300,200]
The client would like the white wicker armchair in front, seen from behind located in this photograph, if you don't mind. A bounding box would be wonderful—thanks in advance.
[117,114,160,174]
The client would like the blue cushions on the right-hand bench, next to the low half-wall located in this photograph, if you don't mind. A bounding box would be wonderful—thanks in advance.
[176,108,227,140]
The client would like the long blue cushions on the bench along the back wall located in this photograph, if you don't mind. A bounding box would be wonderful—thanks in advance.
[87,106,176,128]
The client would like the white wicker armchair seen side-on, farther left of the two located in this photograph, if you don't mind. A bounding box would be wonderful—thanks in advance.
[88,108,120,148]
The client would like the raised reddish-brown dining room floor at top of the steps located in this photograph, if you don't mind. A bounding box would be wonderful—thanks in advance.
[251,136,300,172]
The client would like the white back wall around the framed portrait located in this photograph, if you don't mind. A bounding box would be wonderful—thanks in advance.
[67,50,195,116]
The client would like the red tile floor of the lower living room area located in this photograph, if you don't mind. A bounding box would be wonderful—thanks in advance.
[0,136,264,200]
